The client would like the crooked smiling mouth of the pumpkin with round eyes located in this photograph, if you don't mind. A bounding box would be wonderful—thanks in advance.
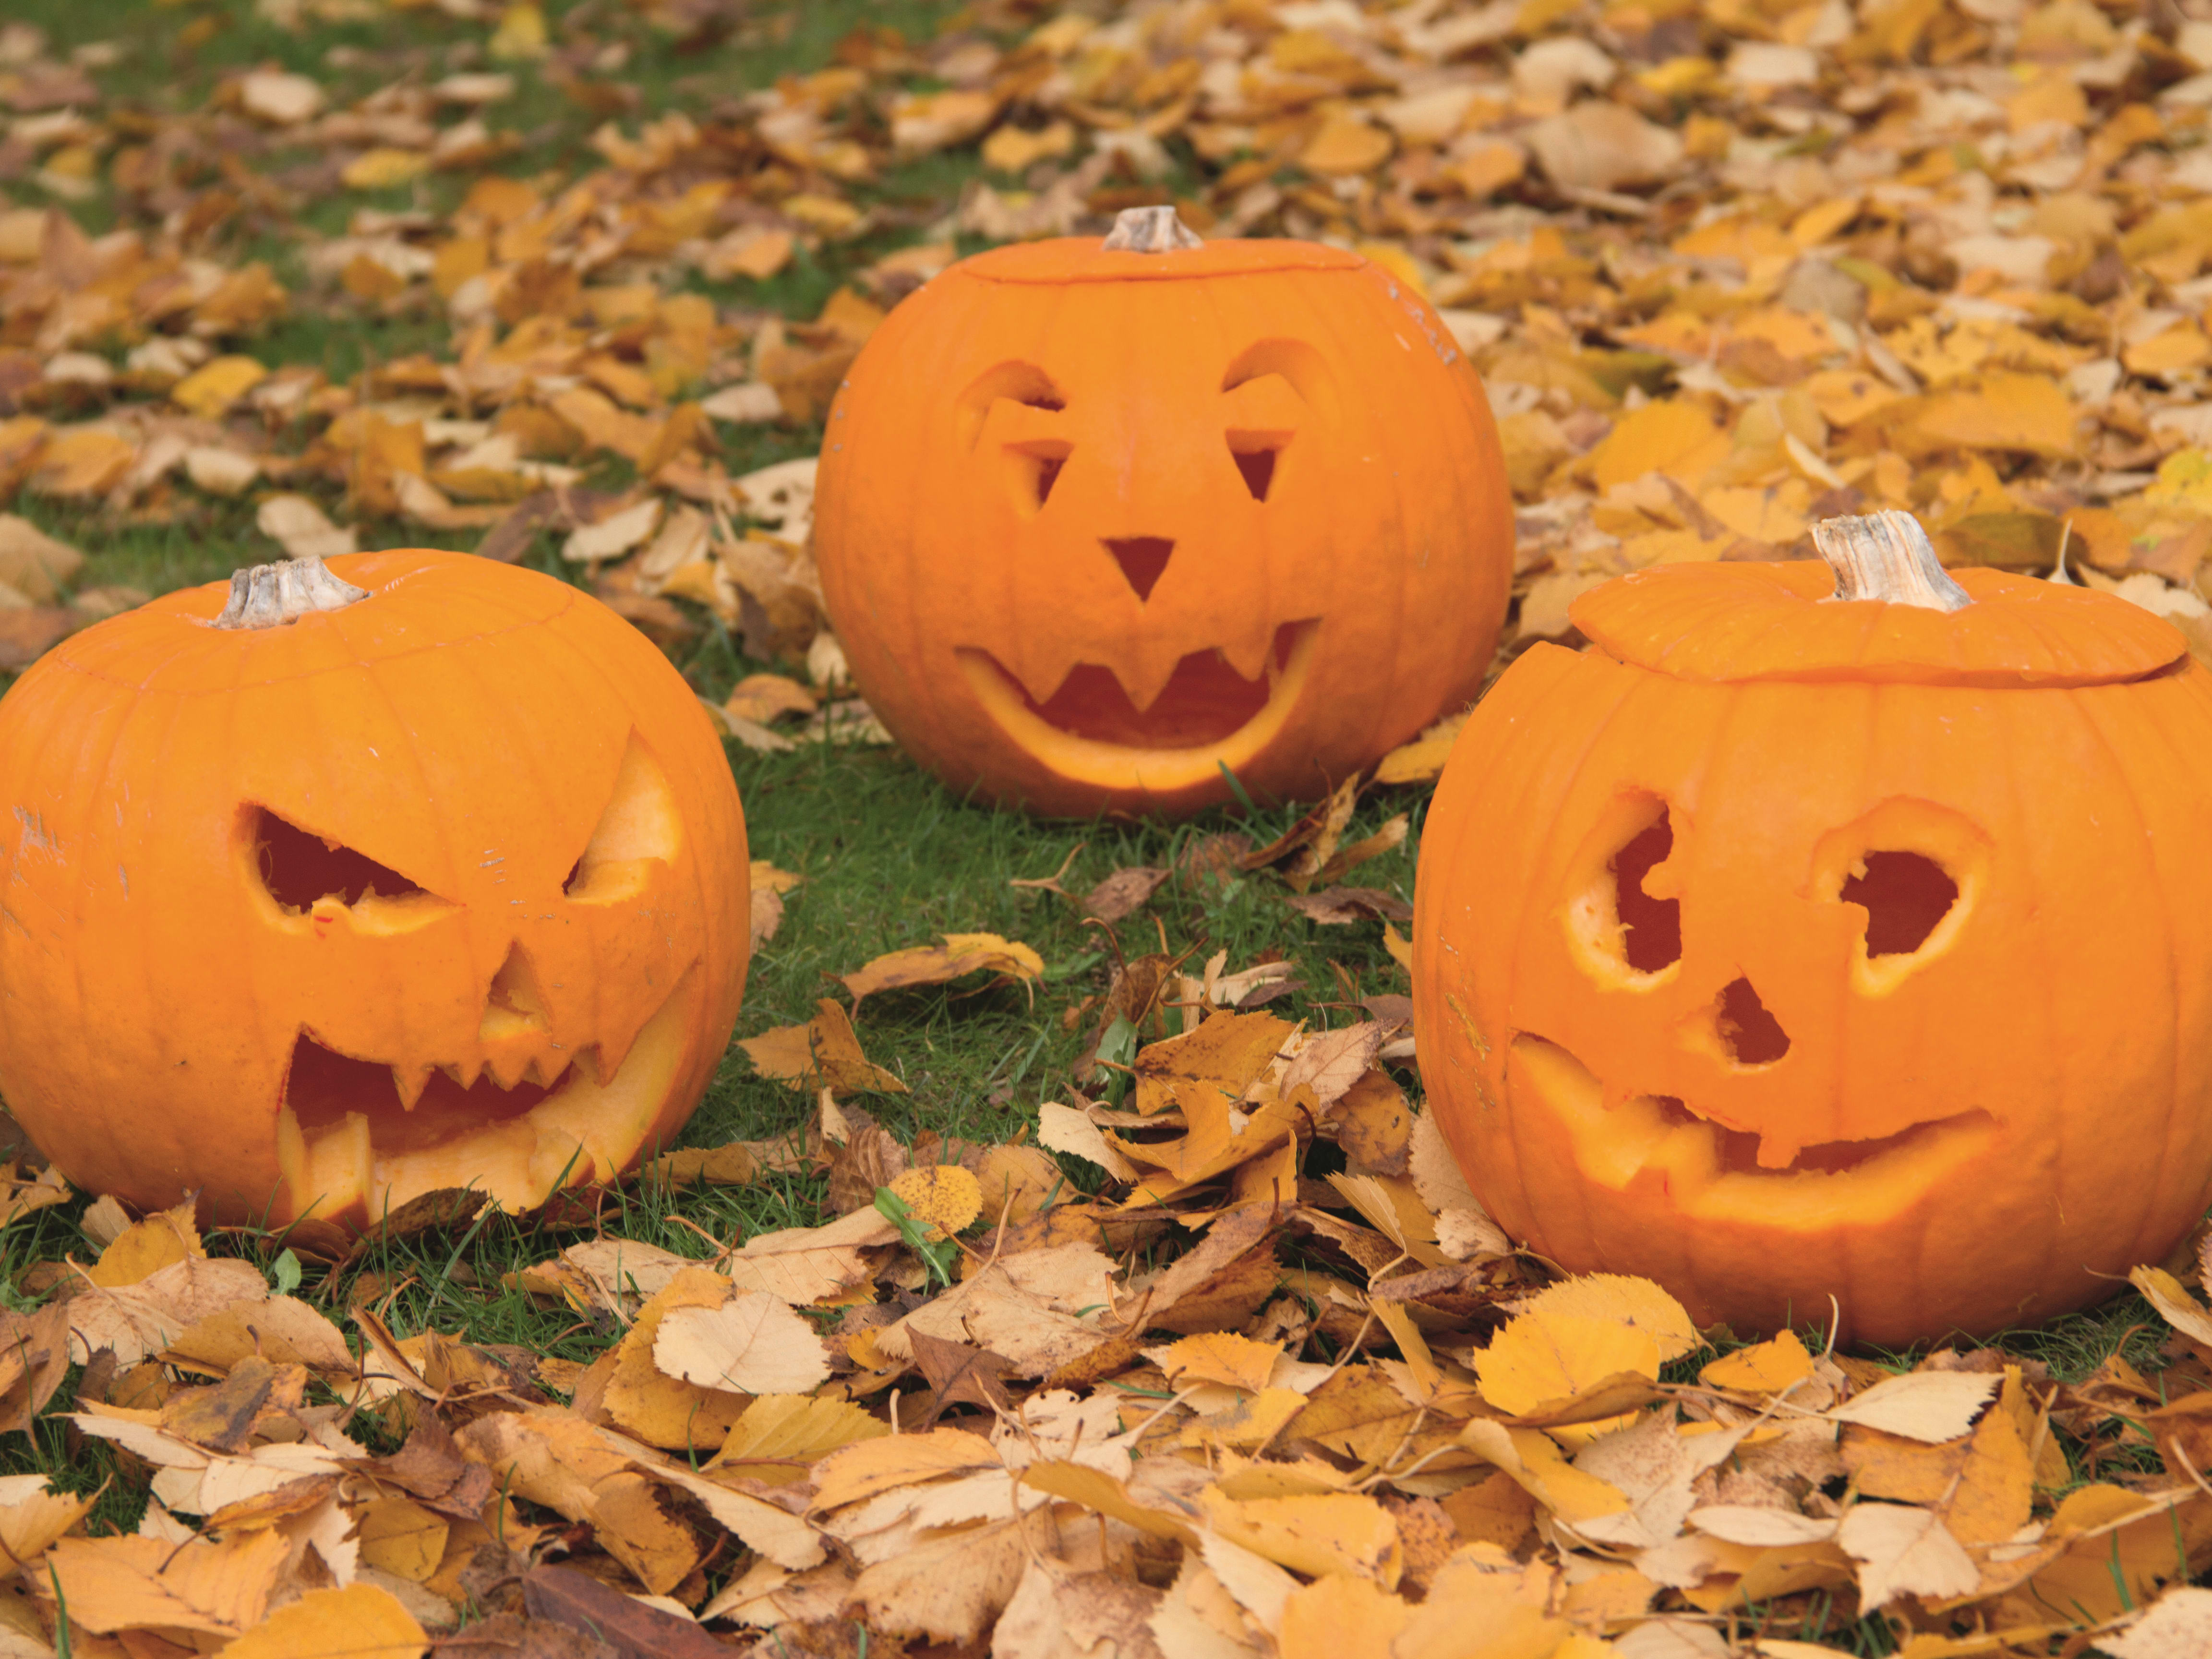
[1511,1031,1997,1226]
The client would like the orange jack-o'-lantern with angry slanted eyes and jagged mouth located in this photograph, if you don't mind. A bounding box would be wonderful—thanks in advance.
[0,551,750,1226]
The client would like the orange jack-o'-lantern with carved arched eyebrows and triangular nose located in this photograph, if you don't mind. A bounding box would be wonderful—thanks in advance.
[814,208,1513,814]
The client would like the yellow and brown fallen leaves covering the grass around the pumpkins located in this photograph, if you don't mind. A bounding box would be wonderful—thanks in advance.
[13,0,2212,1659]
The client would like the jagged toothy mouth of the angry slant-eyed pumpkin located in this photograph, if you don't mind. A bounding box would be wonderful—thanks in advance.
[276,974,695,1219]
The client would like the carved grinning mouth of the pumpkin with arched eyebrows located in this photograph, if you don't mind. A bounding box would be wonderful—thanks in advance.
[958,617,1318,792]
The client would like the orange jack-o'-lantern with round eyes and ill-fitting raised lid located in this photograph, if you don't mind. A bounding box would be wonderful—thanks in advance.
[1414,513,2212,1343]
